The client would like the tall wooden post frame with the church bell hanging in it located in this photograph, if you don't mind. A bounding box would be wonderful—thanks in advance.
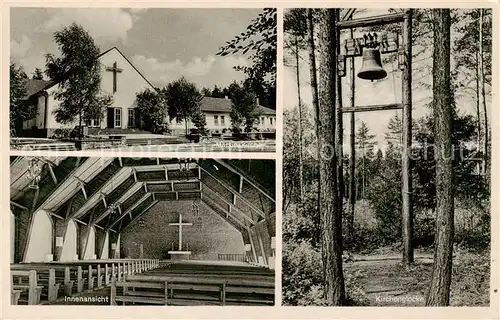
[336,9,414,265]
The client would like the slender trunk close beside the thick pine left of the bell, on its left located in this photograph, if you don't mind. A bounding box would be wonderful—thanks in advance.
[307,9,321,242]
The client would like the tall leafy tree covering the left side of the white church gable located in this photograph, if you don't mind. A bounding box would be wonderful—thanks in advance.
[45,23,113,138]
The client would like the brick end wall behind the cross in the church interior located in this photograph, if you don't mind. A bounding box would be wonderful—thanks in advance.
[121,201,244,260]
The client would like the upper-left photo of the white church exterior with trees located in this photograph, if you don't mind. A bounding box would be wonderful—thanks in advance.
[10,7,277,152]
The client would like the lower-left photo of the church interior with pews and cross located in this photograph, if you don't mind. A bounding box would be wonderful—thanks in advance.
[10,156,276,306]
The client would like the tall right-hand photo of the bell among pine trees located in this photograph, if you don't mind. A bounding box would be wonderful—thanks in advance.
[282,7,492,306]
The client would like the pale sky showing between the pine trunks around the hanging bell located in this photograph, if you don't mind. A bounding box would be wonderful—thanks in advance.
[283,9,491,145]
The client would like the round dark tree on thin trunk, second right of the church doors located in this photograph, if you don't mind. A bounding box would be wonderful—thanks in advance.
[163,77,203,134]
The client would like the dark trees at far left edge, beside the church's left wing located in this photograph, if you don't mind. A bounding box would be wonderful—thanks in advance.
[9,63,37,136]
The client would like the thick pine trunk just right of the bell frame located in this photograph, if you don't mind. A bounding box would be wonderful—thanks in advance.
[426,9,454,306]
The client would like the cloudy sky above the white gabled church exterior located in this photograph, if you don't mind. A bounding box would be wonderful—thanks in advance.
[10,8,261,89]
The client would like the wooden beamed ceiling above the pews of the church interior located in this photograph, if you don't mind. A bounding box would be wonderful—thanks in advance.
[11,157,275,232]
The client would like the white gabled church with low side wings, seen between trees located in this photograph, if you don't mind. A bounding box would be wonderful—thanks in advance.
[21,47,276,137]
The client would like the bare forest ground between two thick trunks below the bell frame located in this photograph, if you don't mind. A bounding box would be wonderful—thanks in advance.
[344,253,433,306]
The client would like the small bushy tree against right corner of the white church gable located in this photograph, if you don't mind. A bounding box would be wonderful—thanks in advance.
[136,89,167,133]
